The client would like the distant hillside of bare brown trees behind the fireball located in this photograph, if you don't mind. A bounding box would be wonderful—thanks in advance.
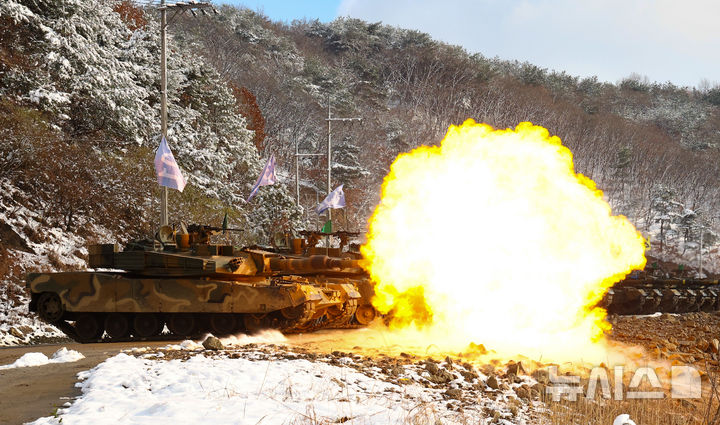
[182,7,720,262]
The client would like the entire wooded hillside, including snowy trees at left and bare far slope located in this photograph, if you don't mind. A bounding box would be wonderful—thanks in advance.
[0,0,720,334]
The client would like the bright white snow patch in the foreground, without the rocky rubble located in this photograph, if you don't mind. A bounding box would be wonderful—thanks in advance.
[28,350,527,425]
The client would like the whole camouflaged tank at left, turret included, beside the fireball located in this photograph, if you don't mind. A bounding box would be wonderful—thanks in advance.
[27,225,374,342]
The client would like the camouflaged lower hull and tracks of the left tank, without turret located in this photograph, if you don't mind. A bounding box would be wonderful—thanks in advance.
[27,272,346,342]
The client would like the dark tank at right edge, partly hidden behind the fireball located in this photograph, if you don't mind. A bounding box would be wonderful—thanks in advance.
[602,256,720,315]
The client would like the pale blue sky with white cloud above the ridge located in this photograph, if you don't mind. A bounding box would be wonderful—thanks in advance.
[223,0,720,88]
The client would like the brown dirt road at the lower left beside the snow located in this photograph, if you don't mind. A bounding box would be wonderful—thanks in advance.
[0,341,183,425]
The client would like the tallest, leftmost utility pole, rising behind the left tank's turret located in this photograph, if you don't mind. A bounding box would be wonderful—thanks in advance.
[159,0,217,226]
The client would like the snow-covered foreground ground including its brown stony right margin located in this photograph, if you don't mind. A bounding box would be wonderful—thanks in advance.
[22,334,538,425]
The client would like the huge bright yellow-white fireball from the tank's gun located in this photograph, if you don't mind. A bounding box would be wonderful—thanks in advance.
[362,120,645,361]
